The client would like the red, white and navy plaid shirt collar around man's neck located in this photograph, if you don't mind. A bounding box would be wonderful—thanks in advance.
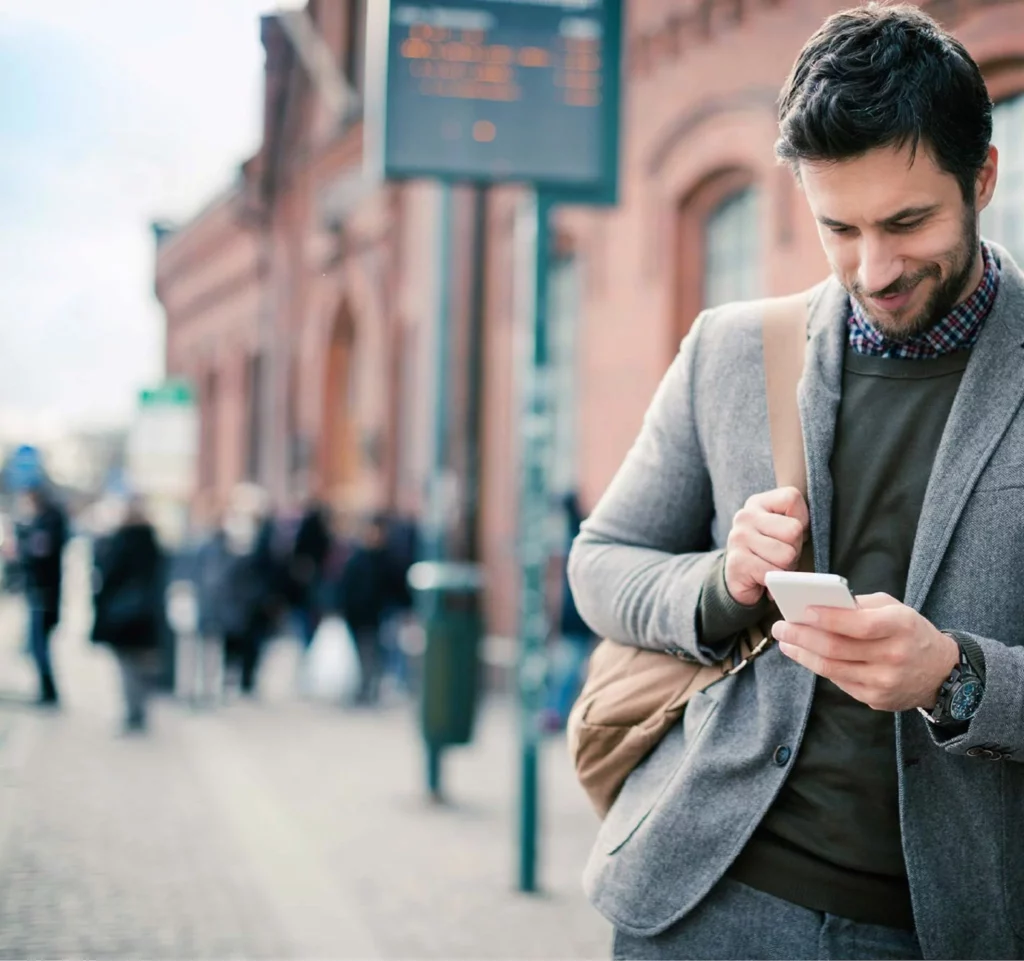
[847,241,999,361]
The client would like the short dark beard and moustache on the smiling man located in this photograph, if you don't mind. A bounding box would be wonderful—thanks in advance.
[847,204,981,343]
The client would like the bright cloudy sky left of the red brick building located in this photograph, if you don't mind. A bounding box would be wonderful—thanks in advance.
[0,0,280,433]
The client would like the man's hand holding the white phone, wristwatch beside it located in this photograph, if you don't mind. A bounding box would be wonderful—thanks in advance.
[772,594,959,712]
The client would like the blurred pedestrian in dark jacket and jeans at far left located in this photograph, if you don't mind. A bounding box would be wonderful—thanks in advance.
[18,481,68,706]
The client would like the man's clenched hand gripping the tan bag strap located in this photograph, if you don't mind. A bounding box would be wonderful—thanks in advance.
[725,488,810,607]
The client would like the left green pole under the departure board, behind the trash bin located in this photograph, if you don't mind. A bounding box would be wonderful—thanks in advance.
[424,182,455,800]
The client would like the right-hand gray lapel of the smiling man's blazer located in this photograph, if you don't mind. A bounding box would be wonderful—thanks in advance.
[905,244,1024,611]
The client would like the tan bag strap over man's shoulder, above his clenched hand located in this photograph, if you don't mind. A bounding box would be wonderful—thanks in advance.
[762,291,808,497]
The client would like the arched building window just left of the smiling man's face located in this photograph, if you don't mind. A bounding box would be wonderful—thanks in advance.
[703,186,761,307]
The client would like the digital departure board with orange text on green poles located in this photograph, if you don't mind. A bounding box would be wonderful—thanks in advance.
[384,0,622,199]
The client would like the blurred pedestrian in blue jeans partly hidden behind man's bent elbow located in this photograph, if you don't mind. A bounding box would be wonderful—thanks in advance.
[544,493,596,732]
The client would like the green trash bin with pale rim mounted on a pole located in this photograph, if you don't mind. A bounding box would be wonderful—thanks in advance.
[409,561,483,749]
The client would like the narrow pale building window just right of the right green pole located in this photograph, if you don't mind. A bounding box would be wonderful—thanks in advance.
[548,254,582,494]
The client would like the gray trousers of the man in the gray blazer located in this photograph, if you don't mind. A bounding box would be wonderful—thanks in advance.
[613,878,922,961]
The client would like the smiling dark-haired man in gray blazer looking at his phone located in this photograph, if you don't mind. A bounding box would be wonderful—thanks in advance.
[570,4,1024,958]
